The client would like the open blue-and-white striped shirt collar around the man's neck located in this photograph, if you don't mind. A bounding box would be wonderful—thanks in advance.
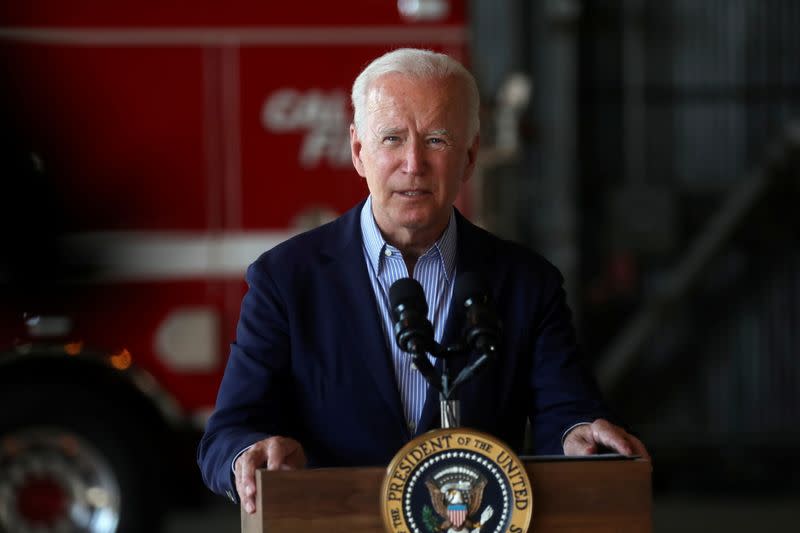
[361,196,458,281]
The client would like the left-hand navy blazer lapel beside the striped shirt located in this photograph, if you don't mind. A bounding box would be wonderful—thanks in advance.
[323,202,406,428]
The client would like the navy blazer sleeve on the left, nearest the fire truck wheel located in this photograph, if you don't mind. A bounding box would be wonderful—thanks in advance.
[197,260,292,500]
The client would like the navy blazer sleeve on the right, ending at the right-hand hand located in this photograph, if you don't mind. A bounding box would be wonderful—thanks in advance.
[530,269,613,454]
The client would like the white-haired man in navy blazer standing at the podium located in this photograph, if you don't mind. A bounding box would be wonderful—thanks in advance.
[198,49,647,512]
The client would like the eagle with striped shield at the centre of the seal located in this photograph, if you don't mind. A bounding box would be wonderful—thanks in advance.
[425,466,494,533]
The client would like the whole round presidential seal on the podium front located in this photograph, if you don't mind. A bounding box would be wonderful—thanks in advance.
[381,428,533,533]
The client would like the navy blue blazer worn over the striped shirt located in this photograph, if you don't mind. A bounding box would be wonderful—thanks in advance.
[198,202,609,494]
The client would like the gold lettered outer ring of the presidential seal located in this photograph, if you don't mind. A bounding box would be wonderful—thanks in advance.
[380,428,533,533]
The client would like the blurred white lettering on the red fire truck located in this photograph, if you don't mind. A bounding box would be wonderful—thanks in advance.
[261,88,351,168]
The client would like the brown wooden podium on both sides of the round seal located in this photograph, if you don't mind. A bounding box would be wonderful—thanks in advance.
[241,456,653,533]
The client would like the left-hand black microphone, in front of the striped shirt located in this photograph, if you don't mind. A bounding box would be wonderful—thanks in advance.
[389,278,442,391]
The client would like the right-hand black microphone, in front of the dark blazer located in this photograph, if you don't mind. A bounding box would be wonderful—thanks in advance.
[453,272,500,389]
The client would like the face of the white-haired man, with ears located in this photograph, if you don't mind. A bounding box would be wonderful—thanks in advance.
[350,74,478,246]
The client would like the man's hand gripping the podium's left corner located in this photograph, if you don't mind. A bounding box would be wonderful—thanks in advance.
[233,437,306,514]
